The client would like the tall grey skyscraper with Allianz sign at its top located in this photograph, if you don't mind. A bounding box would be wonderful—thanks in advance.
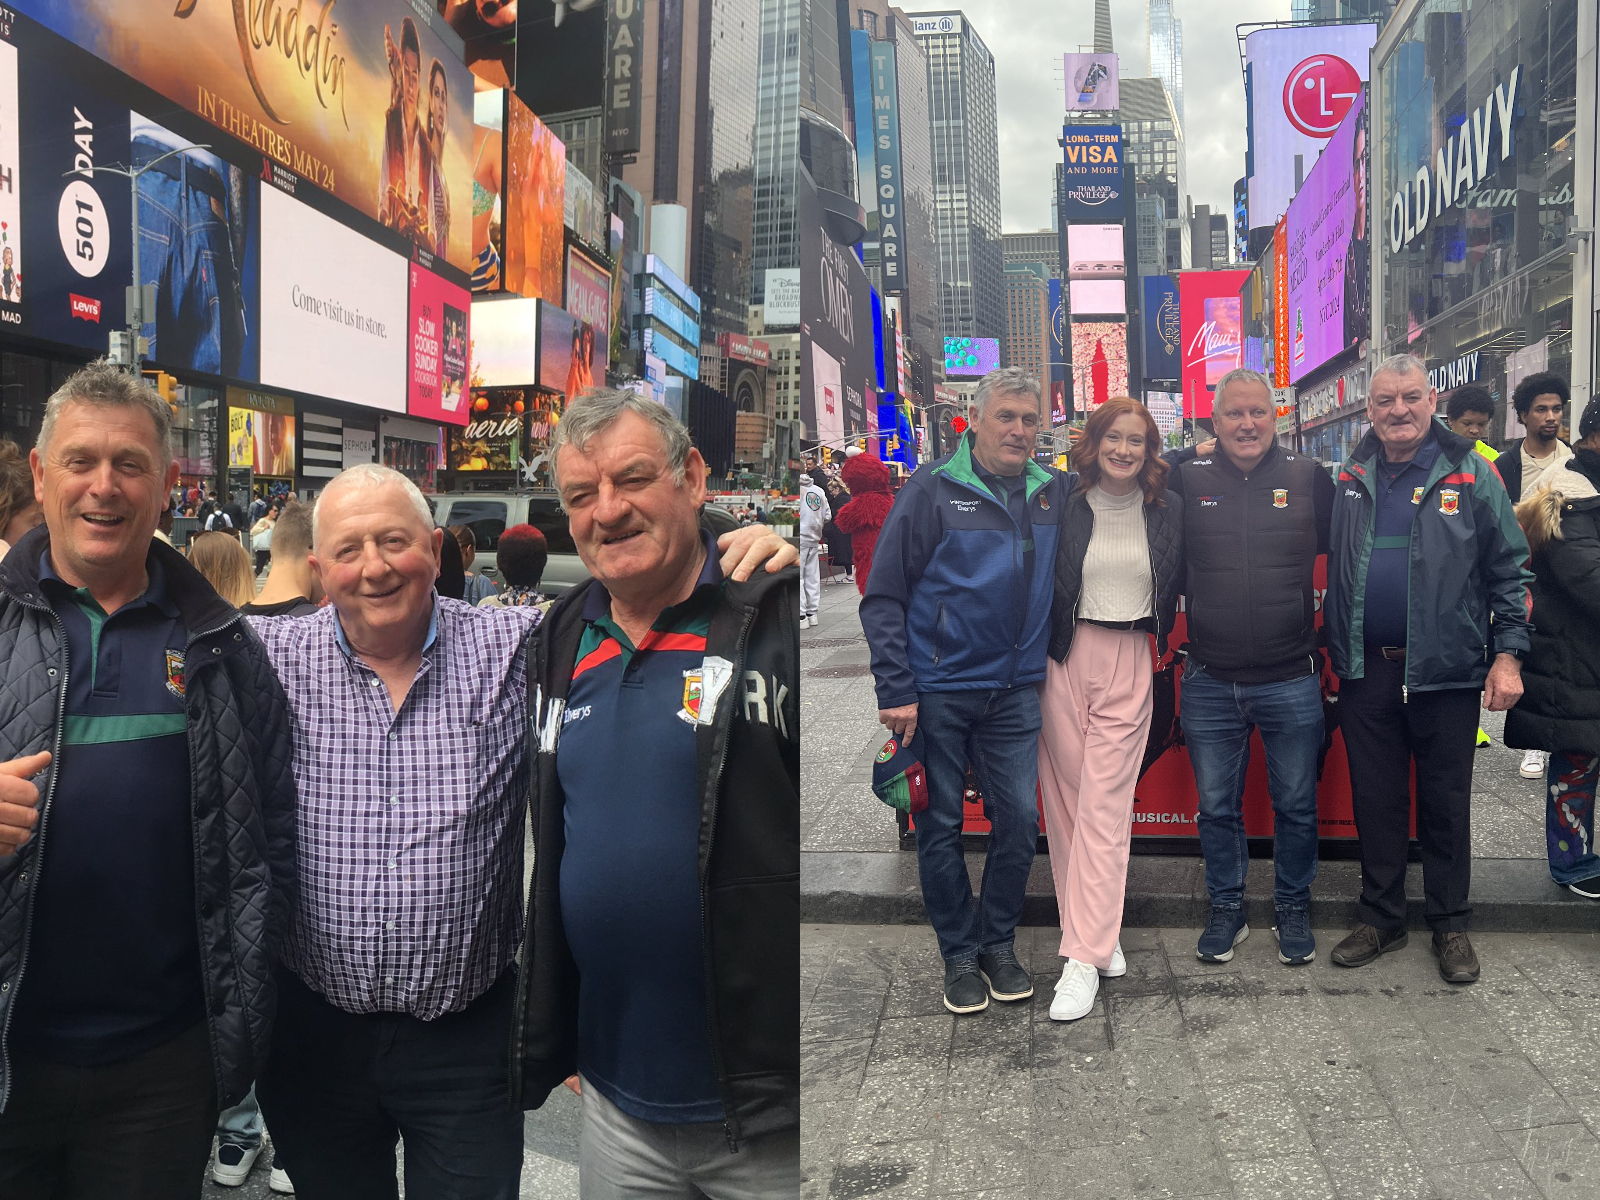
[910,11,1005,347]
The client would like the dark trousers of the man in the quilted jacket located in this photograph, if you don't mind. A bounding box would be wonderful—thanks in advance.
[0,1021,216,1200]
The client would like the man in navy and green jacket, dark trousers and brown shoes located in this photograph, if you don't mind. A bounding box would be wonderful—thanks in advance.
[1323,354,1533,984]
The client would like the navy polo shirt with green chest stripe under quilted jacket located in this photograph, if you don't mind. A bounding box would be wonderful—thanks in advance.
[11,550,205,1066]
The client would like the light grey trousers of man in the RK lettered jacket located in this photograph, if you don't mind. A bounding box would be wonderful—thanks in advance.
[578,1080,800,1200]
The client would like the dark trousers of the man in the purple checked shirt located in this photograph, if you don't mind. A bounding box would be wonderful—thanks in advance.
[256,970,522,1200]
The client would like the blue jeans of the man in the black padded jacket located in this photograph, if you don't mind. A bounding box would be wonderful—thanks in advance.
[1178,659,1323,909]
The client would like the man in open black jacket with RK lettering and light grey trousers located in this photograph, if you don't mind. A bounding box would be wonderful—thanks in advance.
[512,390,800,1200]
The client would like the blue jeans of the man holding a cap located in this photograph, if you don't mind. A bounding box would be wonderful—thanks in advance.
[917,685,1040,962]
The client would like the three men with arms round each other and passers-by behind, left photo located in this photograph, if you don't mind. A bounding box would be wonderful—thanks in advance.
[0,362,798,1200]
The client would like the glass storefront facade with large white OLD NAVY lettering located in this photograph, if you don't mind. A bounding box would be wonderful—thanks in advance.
[1371,0,1592,380]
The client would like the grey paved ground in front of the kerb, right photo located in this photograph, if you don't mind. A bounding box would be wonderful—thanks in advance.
[800,925,1600,1200]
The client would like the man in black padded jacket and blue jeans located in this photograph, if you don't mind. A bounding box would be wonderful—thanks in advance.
[1168,368,1333,966]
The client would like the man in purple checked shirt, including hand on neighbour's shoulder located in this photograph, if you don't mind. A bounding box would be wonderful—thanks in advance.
[254,464,792,1200]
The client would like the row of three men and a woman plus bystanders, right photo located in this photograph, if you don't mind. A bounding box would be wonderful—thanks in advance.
[864,355,1600,1021]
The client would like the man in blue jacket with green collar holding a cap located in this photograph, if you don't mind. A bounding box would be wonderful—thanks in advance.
[861,366,1069,1013]
